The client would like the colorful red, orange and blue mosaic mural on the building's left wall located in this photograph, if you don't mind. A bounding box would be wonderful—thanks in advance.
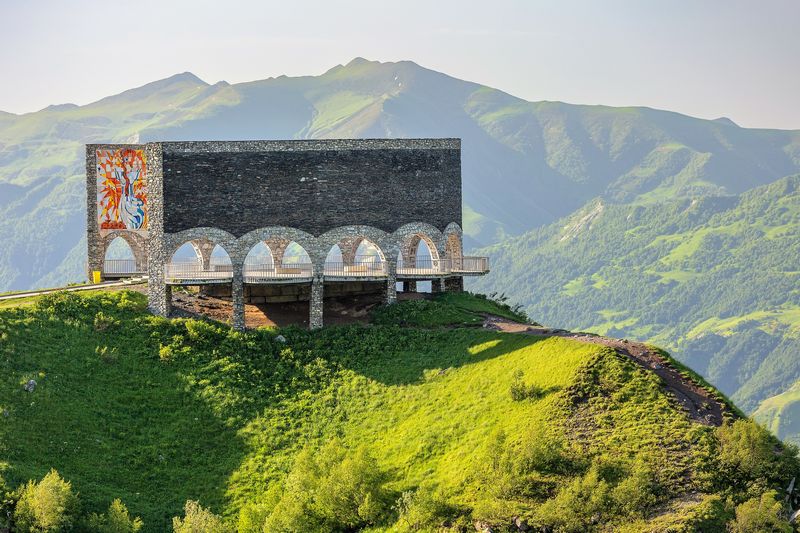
[97,148,147,230]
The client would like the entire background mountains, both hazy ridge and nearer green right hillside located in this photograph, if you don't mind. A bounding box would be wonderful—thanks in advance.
[0,58,800,438]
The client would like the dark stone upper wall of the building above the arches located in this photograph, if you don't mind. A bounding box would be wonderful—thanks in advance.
[161,139,461,237]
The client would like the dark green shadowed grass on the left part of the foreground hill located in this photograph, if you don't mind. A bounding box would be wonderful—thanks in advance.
[0,300,245,531]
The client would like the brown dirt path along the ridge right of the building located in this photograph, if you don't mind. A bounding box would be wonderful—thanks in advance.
[484,315,736,426]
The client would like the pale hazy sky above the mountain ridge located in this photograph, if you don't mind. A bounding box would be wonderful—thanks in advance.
[0,0,800,129]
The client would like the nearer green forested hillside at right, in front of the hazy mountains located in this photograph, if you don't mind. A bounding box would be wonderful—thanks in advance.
[476,176,800,440]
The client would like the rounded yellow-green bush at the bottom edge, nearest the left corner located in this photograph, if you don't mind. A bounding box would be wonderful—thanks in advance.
[14,470,78,532]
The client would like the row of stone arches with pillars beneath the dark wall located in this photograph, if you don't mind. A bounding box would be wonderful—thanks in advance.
[150,222,482,328]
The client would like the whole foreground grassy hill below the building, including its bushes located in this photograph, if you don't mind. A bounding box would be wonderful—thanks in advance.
[0,291,798,531]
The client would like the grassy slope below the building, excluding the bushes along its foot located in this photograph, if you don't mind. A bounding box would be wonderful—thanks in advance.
[0,292,736,531]
